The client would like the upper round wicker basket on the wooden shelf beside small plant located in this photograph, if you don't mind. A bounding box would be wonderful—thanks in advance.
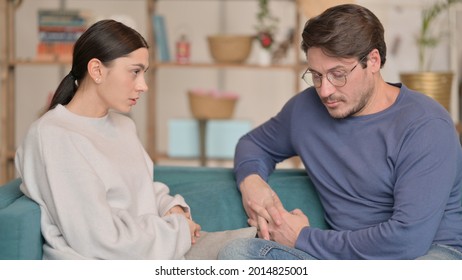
[207,35,254,63]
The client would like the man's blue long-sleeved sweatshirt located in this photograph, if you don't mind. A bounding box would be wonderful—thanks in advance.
[235,84,462,259]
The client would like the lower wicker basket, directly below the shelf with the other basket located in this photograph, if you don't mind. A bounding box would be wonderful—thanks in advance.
[188,91,237,119]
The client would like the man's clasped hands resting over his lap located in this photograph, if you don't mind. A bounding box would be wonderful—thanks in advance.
[241,175,310,248]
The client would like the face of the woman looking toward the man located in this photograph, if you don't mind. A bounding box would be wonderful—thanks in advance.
[97,48,149,113]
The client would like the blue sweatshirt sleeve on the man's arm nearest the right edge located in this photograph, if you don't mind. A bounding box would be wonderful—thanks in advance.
[295,119,460,259]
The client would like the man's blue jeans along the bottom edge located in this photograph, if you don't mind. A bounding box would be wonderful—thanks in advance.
[218,238,462,260]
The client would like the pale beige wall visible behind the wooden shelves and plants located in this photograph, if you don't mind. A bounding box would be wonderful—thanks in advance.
[4,0,462,158]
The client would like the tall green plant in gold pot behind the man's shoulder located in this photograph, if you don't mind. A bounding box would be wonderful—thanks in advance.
[400,0,462,111]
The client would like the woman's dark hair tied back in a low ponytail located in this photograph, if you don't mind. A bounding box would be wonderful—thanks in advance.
[48,19,148,110]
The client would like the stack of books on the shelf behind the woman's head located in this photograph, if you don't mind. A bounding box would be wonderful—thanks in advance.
[37,9,88,61]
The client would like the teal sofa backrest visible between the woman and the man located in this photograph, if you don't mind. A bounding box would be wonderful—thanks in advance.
[154,166,328,231]
